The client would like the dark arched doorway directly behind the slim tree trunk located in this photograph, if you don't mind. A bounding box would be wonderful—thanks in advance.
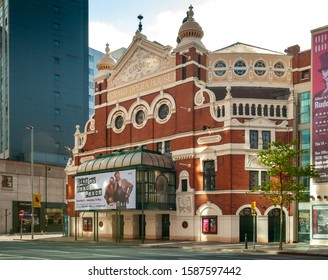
[268,208,286,242]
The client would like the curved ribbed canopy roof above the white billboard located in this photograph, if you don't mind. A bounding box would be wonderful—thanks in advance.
[77,149,174,174]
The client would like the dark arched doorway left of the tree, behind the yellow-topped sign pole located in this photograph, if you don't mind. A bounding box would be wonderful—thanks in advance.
[239,207,257,242]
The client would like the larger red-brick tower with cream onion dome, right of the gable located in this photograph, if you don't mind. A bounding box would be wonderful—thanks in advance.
[174,5,208,81]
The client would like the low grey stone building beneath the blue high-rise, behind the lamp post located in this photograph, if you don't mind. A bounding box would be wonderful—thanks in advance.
[0,159,66,234]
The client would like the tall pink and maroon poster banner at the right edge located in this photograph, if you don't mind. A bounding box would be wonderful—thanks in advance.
[312,27,328,183]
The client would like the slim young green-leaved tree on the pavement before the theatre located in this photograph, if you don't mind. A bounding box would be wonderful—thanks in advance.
[255,141,318,250]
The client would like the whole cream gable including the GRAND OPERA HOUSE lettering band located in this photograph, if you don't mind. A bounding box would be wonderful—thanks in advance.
[108,31,175,102]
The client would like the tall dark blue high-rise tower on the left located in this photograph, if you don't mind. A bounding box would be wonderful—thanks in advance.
[0,0,88,166]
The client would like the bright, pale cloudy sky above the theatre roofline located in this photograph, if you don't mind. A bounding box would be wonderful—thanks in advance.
[89,0,328,52]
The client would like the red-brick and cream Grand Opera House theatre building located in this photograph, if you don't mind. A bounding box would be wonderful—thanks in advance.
[66,7,297,242]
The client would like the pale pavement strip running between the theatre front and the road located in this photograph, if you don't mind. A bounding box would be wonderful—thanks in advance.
[0,233,328,258]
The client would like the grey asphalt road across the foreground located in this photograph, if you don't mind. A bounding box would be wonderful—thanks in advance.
[0,241,327,260]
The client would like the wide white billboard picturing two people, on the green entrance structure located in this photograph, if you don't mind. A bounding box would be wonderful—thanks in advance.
[75,170,136,211]
